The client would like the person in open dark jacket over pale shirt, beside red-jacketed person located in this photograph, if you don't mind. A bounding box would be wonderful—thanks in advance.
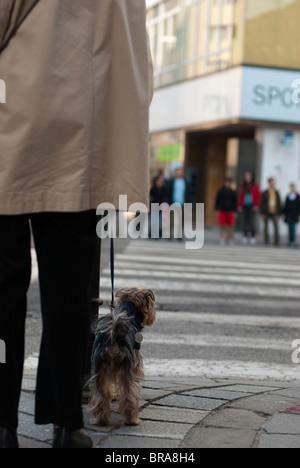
[260,177,282,246]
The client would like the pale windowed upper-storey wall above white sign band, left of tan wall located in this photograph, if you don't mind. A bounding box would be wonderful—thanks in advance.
[147,0,236,88]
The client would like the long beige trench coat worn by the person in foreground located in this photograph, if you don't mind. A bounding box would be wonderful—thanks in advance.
[0,0,152,215]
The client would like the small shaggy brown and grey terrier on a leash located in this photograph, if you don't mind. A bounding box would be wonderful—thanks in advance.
[89,288,156,426]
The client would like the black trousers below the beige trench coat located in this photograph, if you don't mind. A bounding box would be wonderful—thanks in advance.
[0,211,96,430]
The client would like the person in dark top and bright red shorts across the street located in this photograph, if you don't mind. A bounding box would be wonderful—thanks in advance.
[215,177,238,245]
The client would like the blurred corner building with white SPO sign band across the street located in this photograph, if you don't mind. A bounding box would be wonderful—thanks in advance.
[147,0,300,224]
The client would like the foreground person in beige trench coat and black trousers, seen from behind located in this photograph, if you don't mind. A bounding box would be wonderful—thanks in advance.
[0,0,153,448]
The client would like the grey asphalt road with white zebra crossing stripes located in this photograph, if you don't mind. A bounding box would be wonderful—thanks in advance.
[25,236,300,380]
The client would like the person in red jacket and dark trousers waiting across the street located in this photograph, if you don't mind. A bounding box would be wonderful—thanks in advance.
[238,172,261,245]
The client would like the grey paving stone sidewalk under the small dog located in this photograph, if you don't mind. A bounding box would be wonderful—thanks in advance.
[19,375,300,449]
